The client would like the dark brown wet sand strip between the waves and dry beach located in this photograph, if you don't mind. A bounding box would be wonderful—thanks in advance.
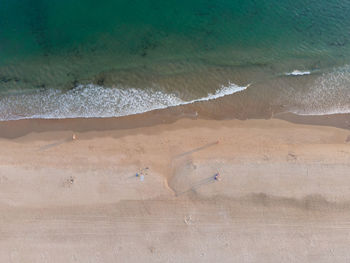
[0,105,350,138]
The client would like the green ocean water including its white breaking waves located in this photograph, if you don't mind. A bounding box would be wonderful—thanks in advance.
[0,0,350,120]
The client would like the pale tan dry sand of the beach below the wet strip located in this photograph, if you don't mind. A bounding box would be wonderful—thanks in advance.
[0,119,350,263]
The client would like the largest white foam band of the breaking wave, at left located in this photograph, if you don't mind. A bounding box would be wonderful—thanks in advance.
[0,83,247,121]
